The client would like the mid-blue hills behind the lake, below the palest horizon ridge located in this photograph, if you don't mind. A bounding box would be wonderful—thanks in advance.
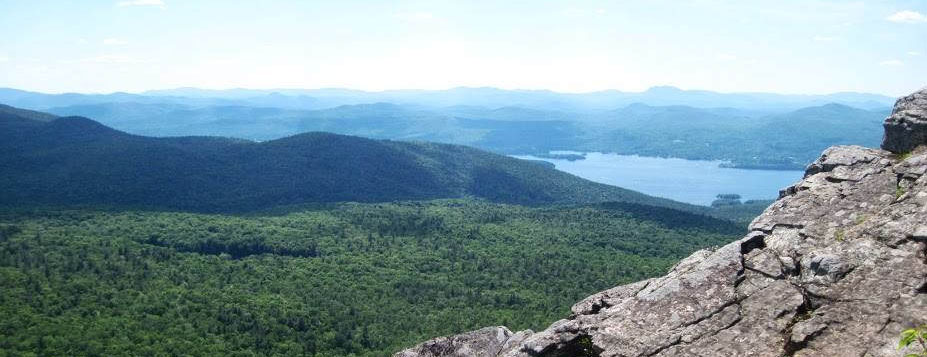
[36,99,888,169]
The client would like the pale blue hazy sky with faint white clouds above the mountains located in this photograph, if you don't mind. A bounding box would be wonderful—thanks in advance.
[0,0,927,96]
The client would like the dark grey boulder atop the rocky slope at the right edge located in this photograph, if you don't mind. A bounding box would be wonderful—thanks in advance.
[882,88,927,153]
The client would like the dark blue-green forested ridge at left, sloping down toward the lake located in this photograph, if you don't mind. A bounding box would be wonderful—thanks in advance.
[0,105,698,212]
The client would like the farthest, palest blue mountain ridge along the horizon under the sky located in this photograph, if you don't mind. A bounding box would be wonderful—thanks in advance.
[0,87,895,112]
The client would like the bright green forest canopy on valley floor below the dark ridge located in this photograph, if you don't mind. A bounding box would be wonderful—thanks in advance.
[0,199,743,356]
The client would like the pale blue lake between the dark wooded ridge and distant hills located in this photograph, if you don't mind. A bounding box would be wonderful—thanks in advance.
[515,151,804,205]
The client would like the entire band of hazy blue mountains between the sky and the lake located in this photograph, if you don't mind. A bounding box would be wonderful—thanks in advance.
[0,87,893,169]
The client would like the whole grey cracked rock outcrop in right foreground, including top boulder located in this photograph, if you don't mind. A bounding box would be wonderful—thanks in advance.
[396,87,927,357]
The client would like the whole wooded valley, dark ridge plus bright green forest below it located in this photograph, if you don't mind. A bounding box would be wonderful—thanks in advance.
[0,102,758,356]
